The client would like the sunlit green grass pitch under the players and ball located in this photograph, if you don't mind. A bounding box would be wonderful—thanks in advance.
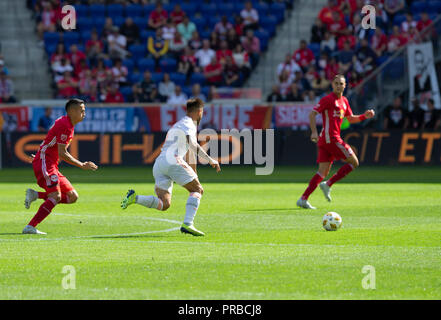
[0,165,441,300]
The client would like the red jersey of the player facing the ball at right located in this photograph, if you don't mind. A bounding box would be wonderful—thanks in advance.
[314,92,352,146]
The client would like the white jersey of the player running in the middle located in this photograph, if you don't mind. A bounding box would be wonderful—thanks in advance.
[159,116,197,159]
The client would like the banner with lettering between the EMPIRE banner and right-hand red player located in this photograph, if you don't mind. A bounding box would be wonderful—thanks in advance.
[274,105,323,128]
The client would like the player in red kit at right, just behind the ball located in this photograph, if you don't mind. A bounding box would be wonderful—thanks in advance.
[297,74,375,209]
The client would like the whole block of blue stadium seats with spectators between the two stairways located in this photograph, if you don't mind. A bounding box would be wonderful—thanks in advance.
[31,0,293,102]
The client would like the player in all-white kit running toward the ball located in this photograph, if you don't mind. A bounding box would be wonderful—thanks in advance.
[121,98,220,236]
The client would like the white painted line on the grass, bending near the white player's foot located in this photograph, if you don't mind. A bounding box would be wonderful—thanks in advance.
[0,213,181,242]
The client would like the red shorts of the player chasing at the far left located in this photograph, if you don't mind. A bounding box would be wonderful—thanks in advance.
[32,159,74,193]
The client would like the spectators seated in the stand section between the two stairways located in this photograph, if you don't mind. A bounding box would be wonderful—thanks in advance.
[30,0,292,102]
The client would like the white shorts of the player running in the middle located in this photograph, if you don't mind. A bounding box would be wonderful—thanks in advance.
[153,157,198,193]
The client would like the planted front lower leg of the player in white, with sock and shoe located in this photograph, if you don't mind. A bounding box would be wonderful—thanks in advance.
[181,177,205,236]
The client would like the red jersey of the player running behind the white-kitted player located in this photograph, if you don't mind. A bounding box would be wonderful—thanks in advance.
[34,116,74,167]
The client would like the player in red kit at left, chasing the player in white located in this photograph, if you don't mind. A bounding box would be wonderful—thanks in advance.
[23,99,98,234]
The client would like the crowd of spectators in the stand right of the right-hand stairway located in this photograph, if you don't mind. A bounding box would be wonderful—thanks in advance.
[267,0,436,101]
